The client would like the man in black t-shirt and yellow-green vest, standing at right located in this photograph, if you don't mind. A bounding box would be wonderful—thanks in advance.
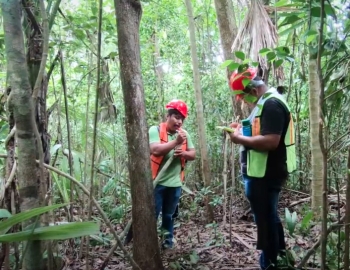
[230,68,296,270]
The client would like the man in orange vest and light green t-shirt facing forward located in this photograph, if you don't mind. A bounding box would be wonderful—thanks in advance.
[149,100,196,250]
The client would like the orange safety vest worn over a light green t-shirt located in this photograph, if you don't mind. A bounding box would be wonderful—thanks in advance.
[151,123,187,182]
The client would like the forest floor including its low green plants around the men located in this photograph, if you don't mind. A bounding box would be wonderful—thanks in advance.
[61,189,345,270]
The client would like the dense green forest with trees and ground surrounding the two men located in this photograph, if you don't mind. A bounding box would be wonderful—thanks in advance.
[0,0,350,270]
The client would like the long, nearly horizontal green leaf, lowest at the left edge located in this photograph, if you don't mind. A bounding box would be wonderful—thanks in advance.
[0,221,100,242]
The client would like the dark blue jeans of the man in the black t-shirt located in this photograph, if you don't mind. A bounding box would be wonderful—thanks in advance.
[243,175,286,270]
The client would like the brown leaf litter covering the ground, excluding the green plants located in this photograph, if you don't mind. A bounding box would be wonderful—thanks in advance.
[63,190,344,270]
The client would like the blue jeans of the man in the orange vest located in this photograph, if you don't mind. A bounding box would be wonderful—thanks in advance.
[154,185,181,247]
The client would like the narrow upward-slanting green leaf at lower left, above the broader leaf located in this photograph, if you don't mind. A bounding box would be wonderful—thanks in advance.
[0,203,67,234]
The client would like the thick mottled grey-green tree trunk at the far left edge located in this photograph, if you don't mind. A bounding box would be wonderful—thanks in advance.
[1,0,43,270]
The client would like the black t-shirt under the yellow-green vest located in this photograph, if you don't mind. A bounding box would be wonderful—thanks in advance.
[241,98,289,184]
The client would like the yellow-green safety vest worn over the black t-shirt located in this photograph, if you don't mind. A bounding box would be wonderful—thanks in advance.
[247,94,297,178]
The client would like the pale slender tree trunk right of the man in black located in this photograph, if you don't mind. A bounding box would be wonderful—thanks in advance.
[309,57,323,214]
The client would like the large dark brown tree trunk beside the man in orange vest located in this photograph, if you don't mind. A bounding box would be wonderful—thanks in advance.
[114,0,163,270]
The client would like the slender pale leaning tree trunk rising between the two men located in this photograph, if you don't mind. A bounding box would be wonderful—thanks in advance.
[185,0,214,223]
